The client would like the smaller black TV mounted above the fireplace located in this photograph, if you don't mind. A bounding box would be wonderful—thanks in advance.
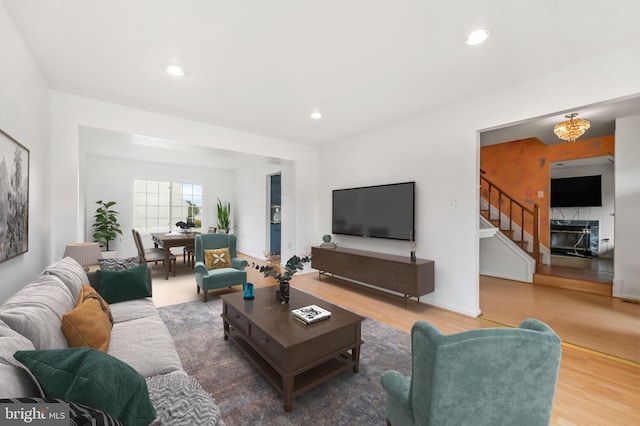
[551,175,602,207]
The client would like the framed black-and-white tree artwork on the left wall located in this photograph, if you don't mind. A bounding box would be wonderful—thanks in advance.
[0,130,29,262]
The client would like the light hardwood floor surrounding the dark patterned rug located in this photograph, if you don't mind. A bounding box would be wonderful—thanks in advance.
[153,259,640,426]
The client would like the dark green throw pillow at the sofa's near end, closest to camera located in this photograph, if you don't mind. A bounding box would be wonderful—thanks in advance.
[14,348,156,426]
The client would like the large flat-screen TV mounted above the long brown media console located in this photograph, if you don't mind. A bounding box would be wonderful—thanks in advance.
[332,182,415,241]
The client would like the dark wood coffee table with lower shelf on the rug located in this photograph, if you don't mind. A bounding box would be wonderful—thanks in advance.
[222,286,364,411]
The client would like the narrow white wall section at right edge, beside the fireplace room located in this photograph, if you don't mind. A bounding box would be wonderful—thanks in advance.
[613,115,640,300]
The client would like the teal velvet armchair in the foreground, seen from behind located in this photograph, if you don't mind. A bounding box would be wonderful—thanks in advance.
[380,318,562,426]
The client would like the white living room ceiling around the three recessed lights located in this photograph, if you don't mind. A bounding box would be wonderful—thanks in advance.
[2,0,640,144]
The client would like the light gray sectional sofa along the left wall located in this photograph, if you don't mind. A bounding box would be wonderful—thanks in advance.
[0,258,223,425]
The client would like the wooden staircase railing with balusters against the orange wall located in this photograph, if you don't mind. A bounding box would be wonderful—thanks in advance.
[480,176,541,269]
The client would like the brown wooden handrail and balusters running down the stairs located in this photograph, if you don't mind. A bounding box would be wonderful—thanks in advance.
[480,175,540,269]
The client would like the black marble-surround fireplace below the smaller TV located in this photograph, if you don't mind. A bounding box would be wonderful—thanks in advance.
[550,220,600,257]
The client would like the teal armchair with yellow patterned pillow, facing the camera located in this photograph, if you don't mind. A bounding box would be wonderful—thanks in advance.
[195,234,249,302]
